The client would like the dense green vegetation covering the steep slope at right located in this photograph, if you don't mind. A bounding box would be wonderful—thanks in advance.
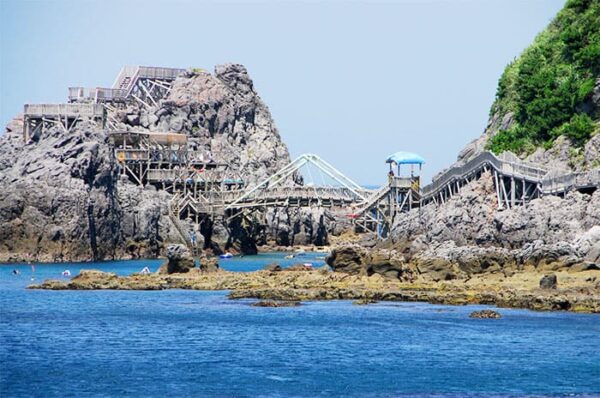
[488,0,600,153]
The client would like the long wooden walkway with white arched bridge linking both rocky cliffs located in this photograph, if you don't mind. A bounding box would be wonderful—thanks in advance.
[111,132,600,237]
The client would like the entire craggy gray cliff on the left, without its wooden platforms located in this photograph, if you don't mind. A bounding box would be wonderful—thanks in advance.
[0,64,289,261]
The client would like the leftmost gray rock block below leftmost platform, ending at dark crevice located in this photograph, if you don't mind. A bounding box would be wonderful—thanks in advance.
[0,123,122,261]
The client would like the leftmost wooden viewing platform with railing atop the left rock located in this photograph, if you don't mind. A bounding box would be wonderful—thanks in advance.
[23,104,106,142]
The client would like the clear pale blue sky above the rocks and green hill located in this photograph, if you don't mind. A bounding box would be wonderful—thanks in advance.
[0,0,564,184]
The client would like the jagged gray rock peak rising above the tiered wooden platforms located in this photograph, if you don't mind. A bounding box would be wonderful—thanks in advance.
[121,64,290,185]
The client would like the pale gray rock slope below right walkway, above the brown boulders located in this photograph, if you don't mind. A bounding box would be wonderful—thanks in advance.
[391,170,600,256]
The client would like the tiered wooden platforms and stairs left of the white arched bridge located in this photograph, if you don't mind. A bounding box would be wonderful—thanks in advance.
[109,131,244,246]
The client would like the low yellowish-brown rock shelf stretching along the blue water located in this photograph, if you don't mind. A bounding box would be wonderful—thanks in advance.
[29,267,600,313]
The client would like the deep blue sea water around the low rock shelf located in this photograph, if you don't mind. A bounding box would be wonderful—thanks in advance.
[0,254,600,397]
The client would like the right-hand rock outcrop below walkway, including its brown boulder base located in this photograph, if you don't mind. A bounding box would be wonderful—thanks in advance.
[328,171,600,281]
